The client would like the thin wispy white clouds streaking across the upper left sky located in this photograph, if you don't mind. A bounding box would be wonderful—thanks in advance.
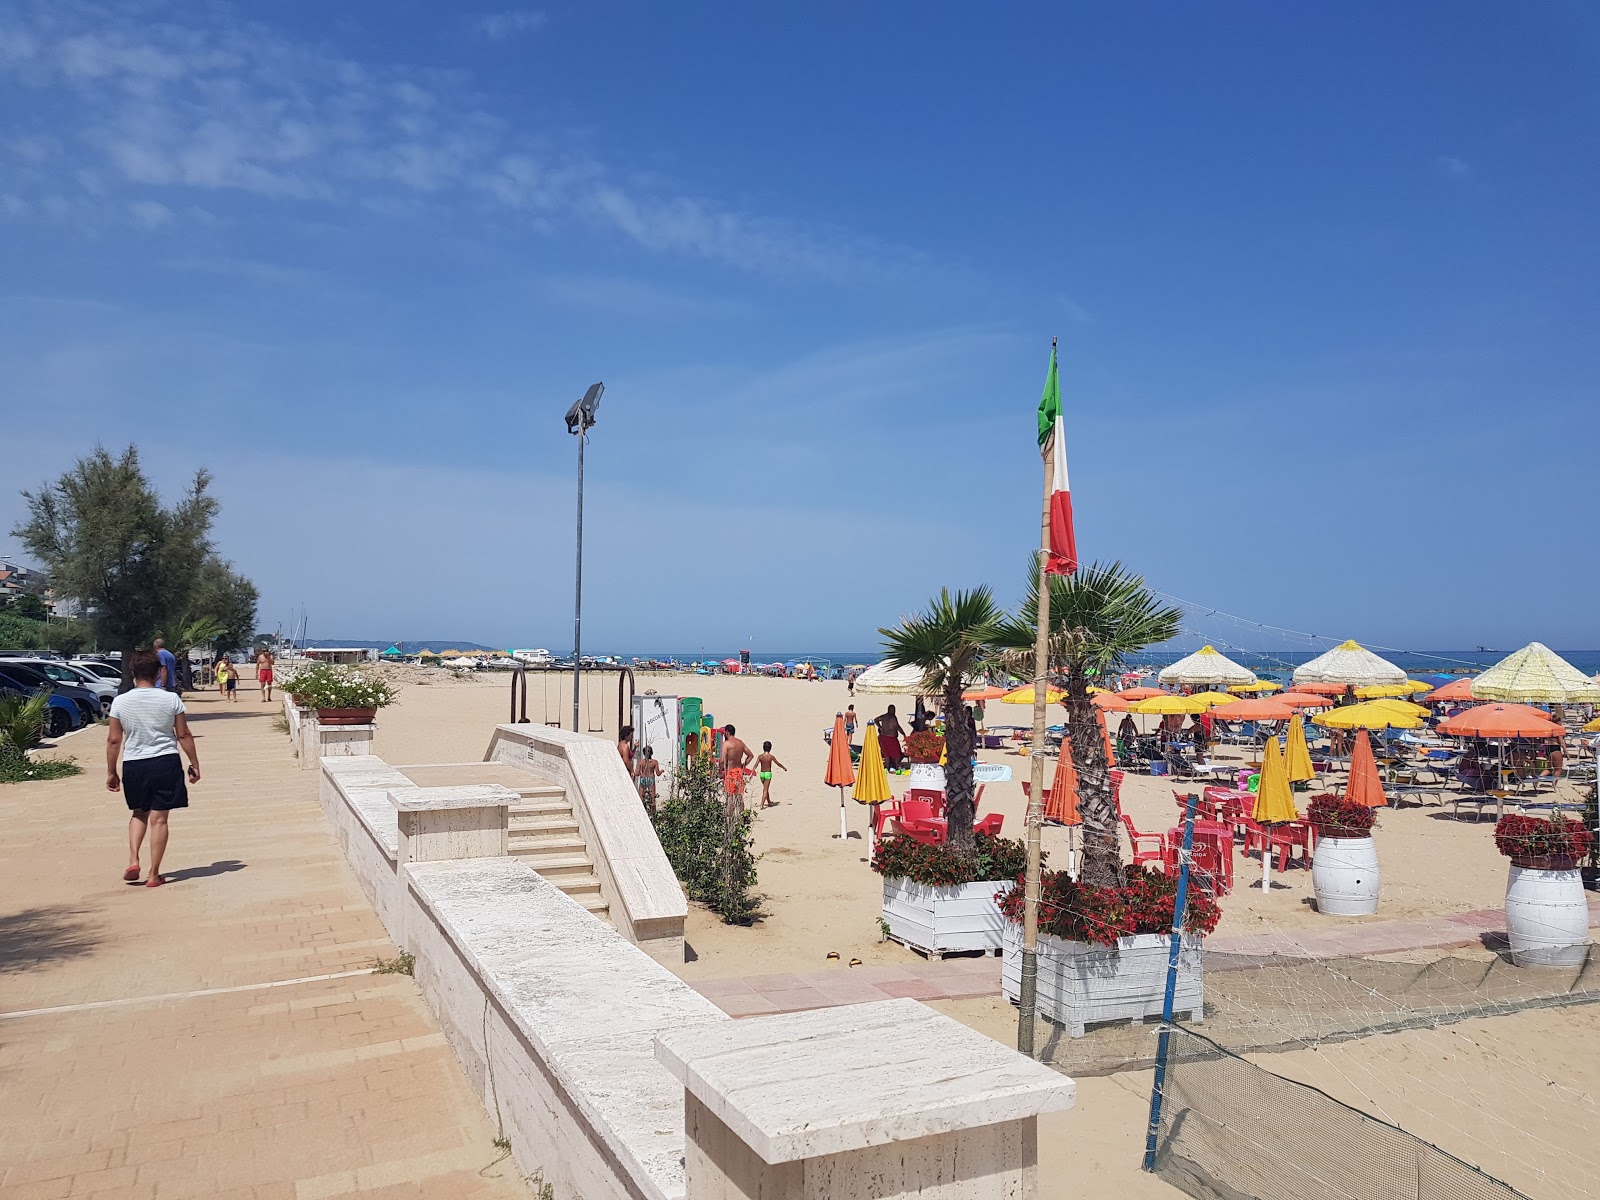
[0,0,918,278]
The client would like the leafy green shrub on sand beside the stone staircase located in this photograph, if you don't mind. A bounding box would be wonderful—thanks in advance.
[653,755,762,925]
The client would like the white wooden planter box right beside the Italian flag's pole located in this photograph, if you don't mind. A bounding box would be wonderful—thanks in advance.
[1000,922,1205,1037]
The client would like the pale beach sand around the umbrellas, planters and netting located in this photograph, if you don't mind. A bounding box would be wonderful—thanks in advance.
[360,672,1600,1198]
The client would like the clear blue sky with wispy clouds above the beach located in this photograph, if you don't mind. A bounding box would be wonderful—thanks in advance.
[0,0,1600,650]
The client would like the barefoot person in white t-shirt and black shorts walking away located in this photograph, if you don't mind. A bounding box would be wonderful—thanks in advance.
[106,650,200,888]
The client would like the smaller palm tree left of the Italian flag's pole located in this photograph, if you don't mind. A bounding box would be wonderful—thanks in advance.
[878,587,1005,858]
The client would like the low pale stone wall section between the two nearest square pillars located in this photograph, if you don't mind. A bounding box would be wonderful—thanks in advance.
[403,858,731,1200]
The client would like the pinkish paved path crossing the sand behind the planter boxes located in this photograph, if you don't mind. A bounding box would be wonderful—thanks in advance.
[691,898,1600,1016]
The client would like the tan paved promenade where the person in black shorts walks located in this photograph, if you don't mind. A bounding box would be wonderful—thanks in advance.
[0,691,528,1200]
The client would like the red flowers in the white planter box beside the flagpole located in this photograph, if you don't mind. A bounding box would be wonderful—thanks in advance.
[995,867,1222,946]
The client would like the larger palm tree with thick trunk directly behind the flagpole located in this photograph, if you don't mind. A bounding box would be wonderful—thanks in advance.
[995,562,1182,886]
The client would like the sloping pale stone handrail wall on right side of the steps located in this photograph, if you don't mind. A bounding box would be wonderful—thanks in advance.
[483,725,688,963]
